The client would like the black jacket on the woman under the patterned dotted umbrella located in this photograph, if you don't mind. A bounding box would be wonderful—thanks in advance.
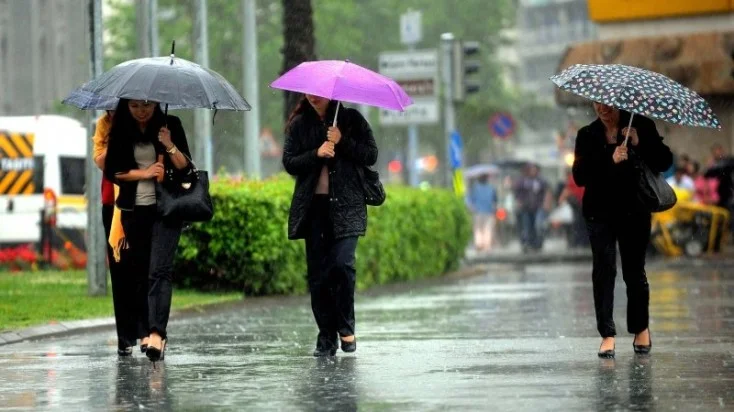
[573,111,673,218]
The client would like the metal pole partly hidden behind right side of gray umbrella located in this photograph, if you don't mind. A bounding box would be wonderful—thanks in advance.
[194,0,214,173]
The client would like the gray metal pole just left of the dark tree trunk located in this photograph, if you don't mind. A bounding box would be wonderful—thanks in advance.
[242,0,261,179]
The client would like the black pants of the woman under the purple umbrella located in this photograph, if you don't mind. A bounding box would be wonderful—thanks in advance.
[306,195,358,349]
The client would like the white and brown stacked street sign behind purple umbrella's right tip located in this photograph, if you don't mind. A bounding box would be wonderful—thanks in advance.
[379,49,439,126]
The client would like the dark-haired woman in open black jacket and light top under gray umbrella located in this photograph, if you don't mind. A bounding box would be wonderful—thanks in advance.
[104,99,191,361]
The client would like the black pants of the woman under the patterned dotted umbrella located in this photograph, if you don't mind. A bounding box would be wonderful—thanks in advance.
[586,214,651,337]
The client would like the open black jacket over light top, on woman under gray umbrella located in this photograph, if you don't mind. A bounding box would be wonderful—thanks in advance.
[104,116,191,210]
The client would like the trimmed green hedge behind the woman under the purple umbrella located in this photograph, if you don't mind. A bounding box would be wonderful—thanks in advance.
[176,175,471,295]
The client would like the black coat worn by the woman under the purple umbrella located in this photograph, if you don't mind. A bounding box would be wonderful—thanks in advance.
[283,102,377,239]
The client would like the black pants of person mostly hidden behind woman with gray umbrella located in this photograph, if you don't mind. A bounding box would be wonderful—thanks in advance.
[102,205,141,349]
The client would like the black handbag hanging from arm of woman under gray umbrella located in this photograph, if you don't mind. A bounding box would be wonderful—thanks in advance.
[156,159,214,222]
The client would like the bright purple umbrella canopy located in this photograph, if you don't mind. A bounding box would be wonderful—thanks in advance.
[270,60,413,111]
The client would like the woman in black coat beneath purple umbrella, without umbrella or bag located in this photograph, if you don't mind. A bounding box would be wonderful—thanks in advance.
[283,94,377,357]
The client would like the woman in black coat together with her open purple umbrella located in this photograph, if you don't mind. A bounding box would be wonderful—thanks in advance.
[270,60,412,357]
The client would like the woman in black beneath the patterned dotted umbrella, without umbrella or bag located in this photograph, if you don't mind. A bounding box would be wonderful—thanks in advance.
[573,102,673,358]
